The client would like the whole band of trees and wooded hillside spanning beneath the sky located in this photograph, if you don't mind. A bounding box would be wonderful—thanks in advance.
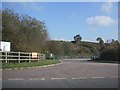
[2,9,120,60]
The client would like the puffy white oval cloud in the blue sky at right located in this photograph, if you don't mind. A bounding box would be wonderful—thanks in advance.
[86,16,115,26]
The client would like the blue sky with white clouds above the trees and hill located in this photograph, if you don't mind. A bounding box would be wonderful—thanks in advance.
[2,2,118,41]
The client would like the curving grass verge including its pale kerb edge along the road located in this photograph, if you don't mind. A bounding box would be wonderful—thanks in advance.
[1,60,61,70]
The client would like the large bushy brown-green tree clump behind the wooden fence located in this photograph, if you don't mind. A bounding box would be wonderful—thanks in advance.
[2,9,49,52]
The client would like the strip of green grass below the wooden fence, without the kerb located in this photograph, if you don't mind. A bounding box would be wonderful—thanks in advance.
[2,60,60,69]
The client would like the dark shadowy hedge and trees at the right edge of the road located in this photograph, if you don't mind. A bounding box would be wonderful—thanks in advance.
[97,37,120,61]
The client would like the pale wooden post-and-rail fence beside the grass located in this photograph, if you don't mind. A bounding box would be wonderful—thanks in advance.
[0,51,45,63]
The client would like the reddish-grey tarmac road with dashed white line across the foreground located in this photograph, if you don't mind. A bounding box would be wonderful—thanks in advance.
[2,59,118,88]
